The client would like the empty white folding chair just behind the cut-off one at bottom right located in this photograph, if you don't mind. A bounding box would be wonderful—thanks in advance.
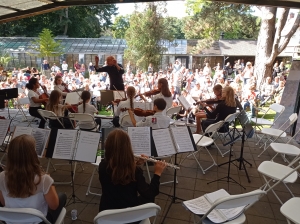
[257,157,300,204]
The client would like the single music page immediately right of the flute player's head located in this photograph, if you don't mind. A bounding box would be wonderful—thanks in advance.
[128,127,151,156]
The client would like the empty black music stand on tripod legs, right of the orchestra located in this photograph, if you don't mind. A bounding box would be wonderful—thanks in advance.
[207,114,246,189]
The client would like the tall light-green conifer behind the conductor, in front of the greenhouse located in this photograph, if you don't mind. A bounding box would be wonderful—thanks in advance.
[124,2,173,70]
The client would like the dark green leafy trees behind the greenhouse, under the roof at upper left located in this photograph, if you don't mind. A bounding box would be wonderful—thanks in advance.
[0,4,117,38]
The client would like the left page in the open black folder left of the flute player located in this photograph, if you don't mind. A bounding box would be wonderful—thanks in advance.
[52,129,77,159]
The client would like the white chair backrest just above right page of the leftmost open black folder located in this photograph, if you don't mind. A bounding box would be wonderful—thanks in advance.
[69,113,98,131]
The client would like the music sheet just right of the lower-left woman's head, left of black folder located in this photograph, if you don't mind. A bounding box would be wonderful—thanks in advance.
[31,128,50,157]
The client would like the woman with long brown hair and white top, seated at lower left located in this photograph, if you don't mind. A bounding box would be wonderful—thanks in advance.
[0,135,67,223]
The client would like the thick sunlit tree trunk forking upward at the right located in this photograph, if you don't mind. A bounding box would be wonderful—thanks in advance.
[254,7,300,86]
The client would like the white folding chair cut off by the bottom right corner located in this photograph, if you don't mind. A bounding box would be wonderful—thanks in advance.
[280,197,300,224]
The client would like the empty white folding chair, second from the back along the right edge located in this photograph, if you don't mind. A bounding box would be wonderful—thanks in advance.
[256,113,298,157]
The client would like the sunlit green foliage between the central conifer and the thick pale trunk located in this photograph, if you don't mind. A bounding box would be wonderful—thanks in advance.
[183,0,260,52]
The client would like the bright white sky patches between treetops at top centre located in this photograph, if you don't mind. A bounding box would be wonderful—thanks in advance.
[116,1,186,18]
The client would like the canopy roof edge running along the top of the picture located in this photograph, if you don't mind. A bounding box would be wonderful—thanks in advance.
[0,0,300,23]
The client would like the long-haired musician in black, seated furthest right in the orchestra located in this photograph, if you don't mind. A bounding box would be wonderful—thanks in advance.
[201,86,237,131]
